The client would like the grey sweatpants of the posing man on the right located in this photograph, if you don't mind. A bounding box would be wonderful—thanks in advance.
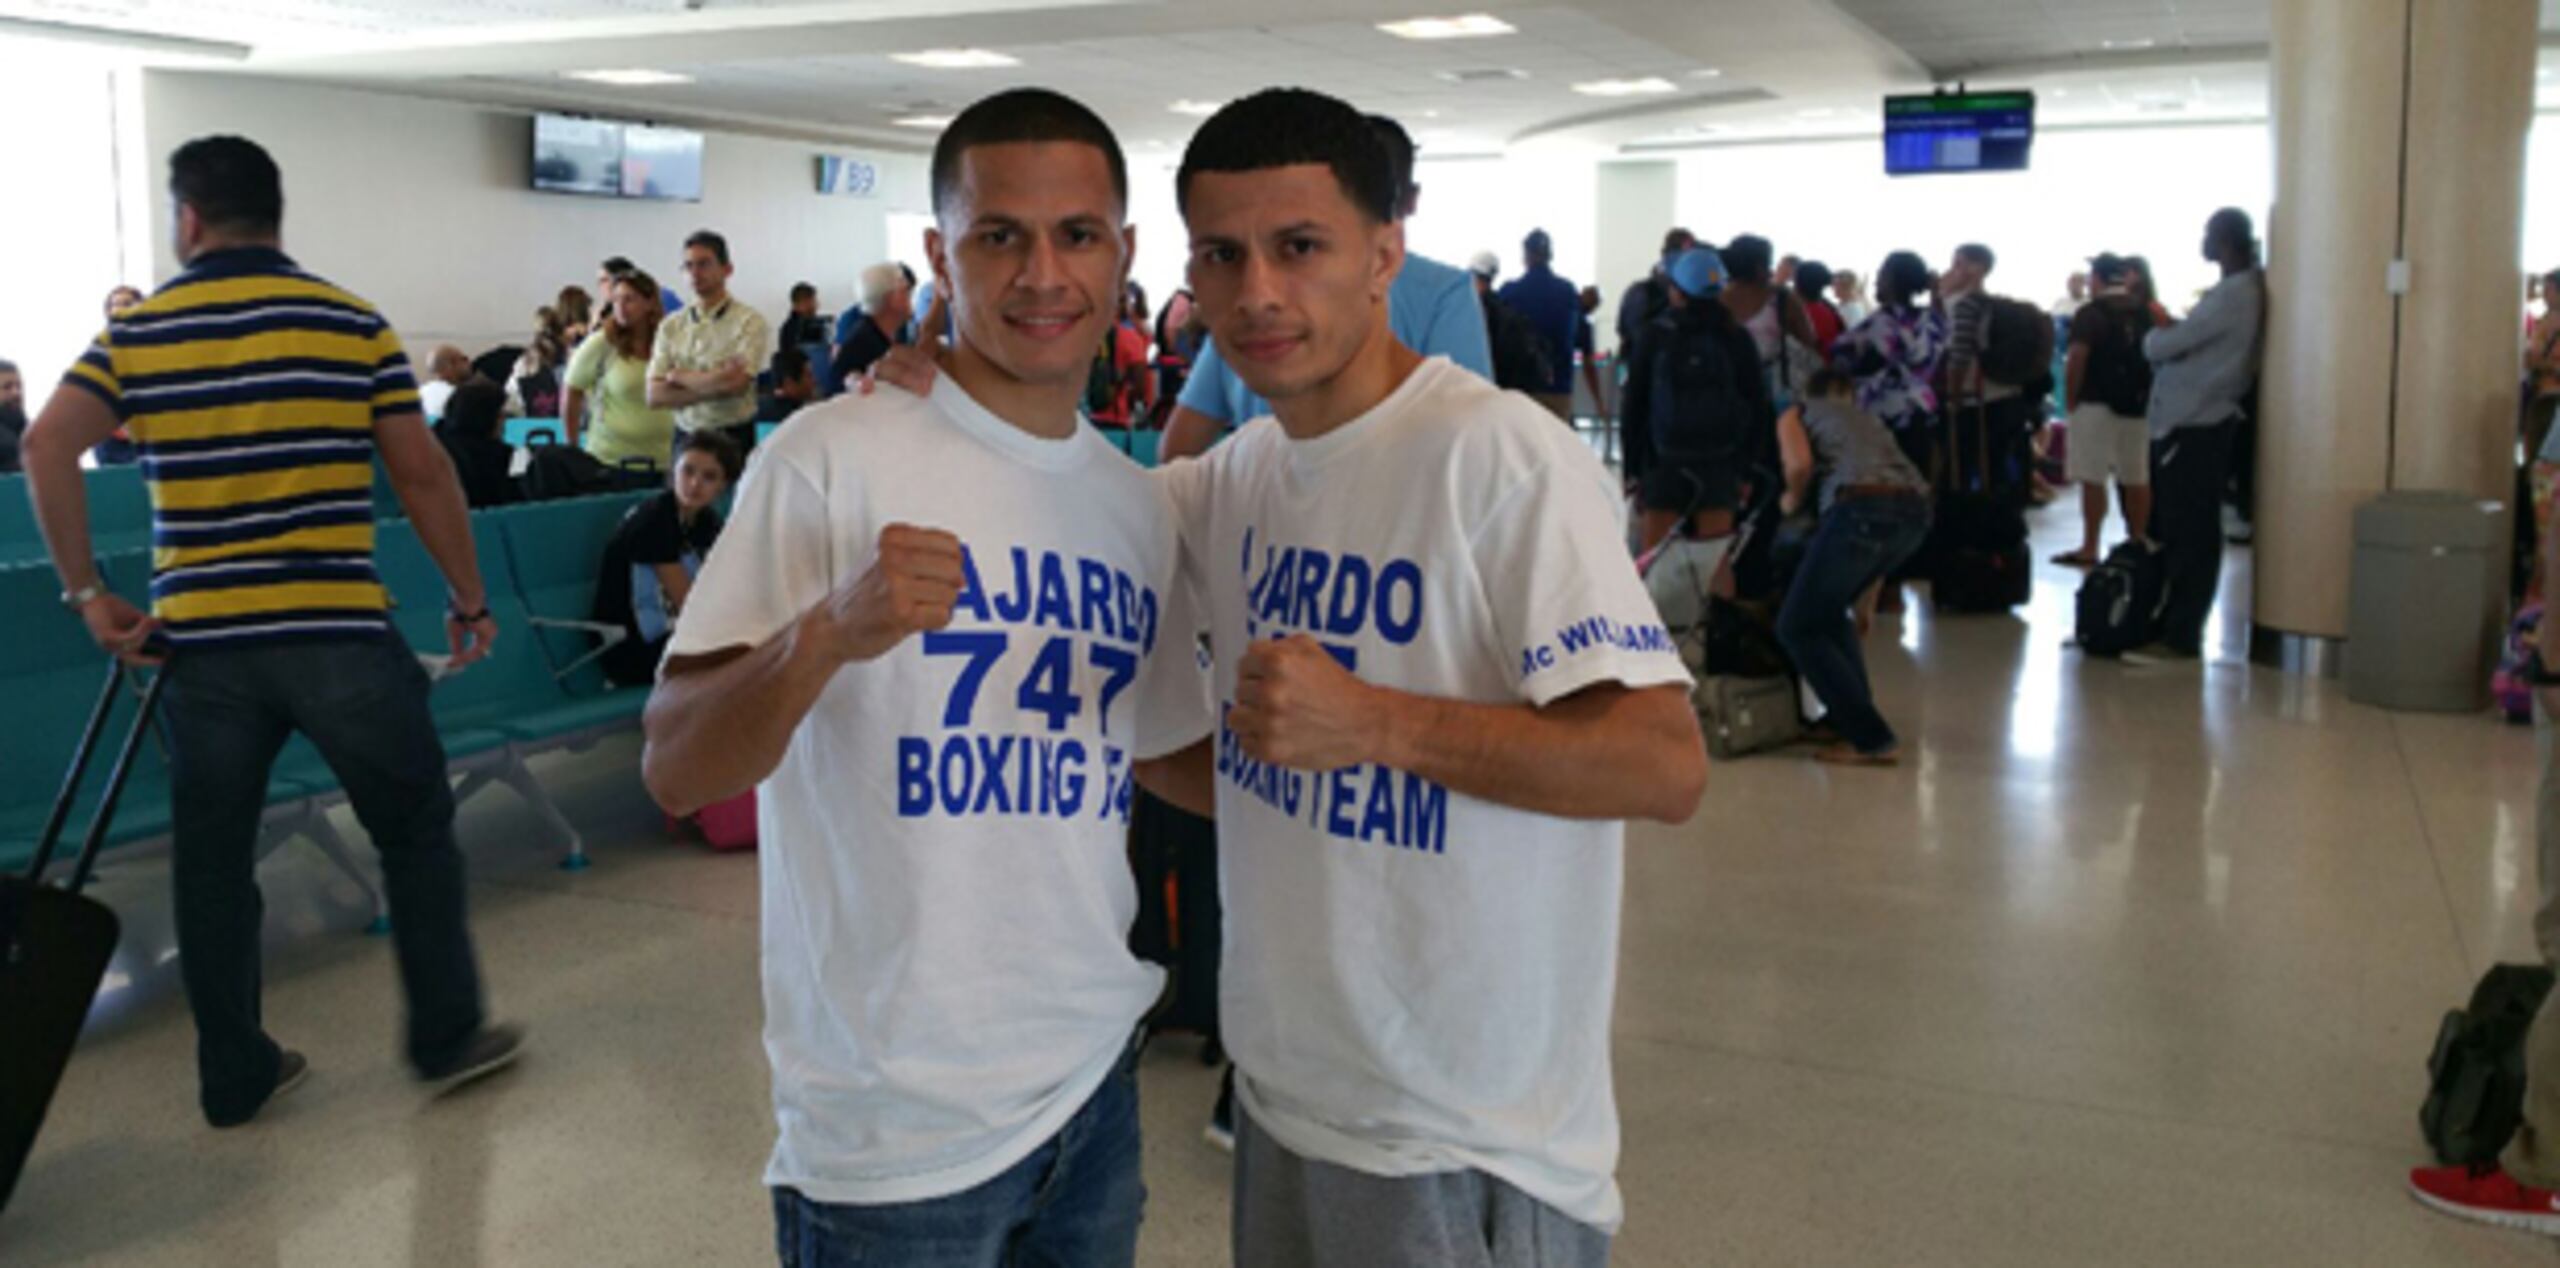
[1234,1101,1610,1268]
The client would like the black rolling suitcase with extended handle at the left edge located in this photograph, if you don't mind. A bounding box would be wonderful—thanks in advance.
[0,663,169,1209]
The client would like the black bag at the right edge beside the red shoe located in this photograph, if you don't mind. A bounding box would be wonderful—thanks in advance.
[2417,963,2552,1166]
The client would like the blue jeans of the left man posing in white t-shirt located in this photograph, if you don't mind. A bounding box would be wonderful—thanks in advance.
[773,1045,1147,1268]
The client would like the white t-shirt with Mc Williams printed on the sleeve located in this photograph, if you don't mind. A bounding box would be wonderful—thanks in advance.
[1157,359,1690,1230]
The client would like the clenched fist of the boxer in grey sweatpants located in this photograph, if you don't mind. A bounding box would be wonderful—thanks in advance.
[1226,635,1388,771]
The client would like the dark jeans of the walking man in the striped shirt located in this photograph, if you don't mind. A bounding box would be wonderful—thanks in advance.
[169,633,481,1122]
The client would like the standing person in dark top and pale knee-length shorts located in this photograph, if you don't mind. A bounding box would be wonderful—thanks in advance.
[2053,256,2150,569]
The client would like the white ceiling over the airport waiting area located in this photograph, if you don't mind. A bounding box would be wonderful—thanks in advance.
[0,0,2560,154]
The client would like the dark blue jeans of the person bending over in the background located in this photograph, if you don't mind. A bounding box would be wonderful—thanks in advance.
[1777,497,1928,753]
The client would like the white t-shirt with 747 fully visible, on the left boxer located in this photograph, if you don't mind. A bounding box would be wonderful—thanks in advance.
[668,377,1211,1204]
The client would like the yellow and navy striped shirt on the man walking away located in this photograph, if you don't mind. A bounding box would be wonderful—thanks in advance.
[64,248,417,646]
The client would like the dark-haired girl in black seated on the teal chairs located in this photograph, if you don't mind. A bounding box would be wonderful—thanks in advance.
[594,430,745,687]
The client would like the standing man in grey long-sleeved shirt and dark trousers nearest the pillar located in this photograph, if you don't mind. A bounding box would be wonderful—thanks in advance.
[2140,207,2266,661]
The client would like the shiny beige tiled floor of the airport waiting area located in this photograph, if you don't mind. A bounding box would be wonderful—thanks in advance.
[0,502,2555,1268]
